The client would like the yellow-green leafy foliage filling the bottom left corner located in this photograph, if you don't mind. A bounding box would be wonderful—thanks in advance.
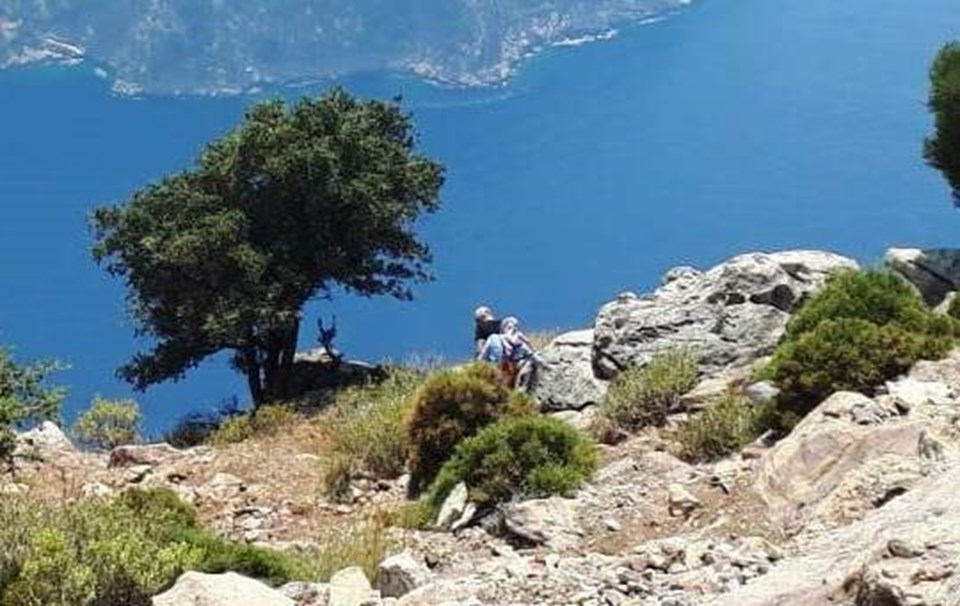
[0,489,312,606]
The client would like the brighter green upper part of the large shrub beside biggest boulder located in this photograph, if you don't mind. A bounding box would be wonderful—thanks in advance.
[783,270,955,342]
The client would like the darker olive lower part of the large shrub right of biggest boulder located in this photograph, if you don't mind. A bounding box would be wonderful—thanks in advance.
[771,318,953,417]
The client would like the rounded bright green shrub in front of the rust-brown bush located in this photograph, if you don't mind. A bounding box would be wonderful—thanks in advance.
[428,417,597,507]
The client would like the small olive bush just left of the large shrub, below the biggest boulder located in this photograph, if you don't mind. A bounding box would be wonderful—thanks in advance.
[672,394,778,463]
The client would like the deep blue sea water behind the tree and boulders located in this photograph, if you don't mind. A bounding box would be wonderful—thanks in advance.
[0,0,960,431]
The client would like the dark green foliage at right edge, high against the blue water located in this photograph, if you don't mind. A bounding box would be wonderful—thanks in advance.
[923,42,960,204]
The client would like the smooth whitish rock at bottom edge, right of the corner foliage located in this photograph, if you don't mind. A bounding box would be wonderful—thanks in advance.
[152,571,295,606]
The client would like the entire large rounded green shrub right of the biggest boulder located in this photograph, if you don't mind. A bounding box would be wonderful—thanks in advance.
[764,270,956,418]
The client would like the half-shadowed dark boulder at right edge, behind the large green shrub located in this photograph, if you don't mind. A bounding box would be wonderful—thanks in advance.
[884,248,960,307]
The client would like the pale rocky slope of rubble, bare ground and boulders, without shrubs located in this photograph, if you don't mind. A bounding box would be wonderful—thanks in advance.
[3,251,960,606]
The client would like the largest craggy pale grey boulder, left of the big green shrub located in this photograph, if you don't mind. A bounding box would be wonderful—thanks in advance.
[593,251,857,379]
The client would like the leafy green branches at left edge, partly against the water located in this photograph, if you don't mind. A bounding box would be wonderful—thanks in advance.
[0,347,66,461]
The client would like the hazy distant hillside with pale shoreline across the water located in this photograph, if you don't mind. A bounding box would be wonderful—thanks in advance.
[0,0,690,93]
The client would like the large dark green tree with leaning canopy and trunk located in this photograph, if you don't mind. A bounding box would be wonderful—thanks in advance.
[93,89,443,403]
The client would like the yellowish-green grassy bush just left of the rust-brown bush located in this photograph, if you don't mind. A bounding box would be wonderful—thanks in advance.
[323,368,425,496]
